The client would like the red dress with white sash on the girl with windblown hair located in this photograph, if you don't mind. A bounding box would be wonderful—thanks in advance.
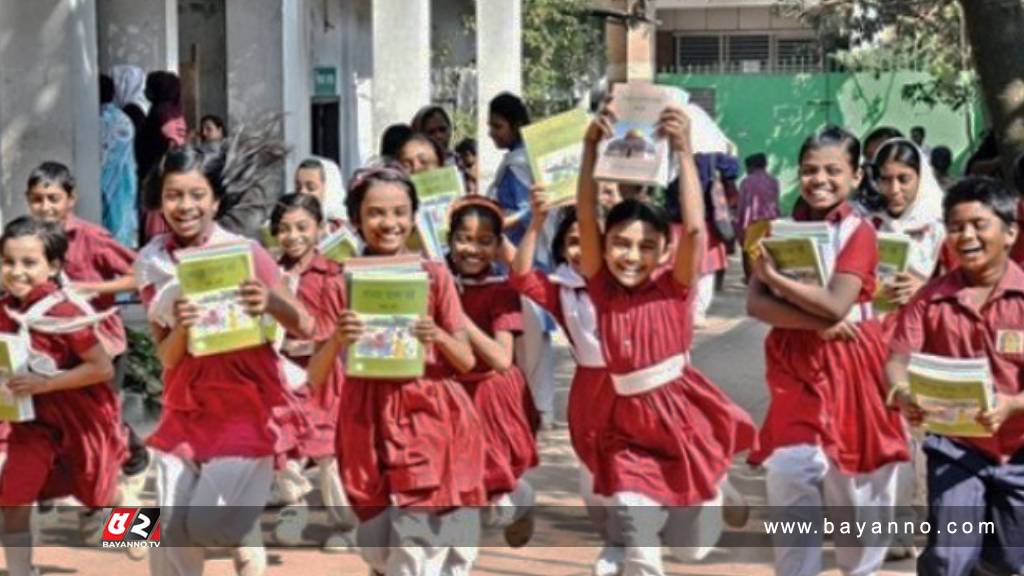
[136,225,306,462]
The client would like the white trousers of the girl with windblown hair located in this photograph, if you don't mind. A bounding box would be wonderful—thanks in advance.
[150,452,273,576]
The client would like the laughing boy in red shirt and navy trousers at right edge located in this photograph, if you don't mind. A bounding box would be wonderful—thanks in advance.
[886,178,1024,575]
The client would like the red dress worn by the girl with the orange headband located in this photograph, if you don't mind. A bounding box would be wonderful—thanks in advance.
[457,278,540,499]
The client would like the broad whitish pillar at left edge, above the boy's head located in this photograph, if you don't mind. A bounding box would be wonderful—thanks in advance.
[0,0,101,221]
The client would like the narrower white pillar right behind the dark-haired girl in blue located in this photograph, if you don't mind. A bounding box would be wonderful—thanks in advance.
[476,0,522,191]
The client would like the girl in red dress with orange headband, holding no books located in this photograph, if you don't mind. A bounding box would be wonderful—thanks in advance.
[449,197,539,547]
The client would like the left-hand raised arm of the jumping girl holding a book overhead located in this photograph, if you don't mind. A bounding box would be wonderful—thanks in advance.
[577,107,614,278]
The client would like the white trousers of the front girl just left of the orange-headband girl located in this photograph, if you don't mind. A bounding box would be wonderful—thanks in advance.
[356,507,480,576]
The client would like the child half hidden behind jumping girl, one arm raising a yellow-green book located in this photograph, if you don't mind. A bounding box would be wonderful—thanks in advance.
[509,194,624,576]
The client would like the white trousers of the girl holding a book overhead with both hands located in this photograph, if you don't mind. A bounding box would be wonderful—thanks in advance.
[608,483,722,576]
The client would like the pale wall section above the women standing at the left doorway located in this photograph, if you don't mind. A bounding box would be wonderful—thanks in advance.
[95,0,178,72]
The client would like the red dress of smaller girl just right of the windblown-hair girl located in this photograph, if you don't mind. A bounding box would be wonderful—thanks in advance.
[281,254,345,460]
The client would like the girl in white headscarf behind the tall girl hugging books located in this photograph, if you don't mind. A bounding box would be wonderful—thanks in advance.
[868,138,951,561]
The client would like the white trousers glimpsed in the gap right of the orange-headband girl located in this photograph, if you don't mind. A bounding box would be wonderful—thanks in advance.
[515,297,555,417]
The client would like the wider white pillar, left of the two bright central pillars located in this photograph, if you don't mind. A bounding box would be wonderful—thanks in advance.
[373,0,430,150]
